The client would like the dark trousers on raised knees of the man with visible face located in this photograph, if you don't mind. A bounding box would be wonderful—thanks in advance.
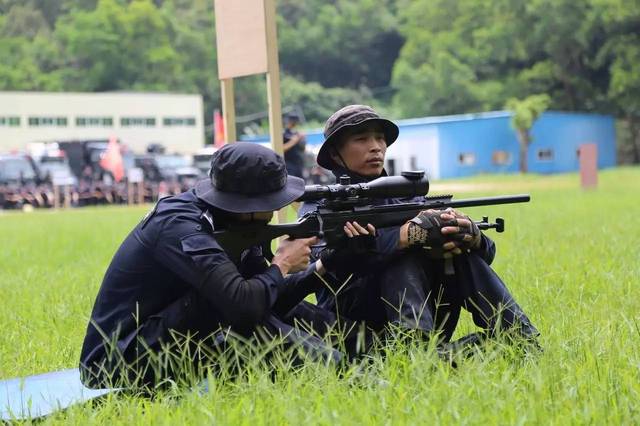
[322,251,539,341]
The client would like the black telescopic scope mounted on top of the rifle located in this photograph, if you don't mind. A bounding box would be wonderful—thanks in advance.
[297,170,429,201]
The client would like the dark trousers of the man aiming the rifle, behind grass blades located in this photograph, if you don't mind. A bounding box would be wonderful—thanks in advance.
[82,291,372,387]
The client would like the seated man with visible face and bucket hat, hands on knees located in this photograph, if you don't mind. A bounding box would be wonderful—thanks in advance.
[299,105,538,349]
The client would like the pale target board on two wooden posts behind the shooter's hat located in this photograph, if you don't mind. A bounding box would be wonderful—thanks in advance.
[215,0,286,223]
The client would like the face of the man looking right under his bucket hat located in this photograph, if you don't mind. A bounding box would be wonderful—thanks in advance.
[331,124,387,177]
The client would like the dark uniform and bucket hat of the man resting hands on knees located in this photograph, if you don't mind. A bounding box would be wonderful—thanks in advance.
[300,105,538,341]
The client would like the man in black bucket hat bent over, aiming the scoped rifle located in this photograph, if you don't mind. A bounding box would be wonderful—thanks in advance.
[80,143,370,386]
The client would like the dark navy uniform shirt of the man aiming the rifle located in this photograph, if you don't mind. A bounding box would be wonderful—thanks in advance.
[81,190,321,365]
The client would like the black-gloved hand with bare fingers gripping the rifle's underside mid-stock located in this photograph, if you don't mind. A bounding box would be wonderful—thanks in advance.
[320,222,376,272]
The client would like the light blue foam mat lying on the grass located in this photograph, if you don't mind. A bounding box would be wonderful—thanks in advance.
[0,368,114,420]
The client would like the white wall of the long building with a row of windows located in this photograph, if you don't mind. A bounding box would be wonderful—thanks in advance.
[0,92,204,153]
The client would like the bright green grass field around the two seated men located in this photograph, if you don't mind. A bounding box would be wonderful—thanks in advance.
[0,168,640,425]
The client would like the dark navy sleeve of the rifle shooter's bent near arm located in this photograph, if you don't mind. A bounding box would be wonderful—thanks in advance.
[154,217,283,330]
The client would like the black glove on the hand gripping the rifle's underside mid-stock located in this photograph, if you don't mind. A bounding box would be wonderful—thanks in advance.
[320,234,376,273]
